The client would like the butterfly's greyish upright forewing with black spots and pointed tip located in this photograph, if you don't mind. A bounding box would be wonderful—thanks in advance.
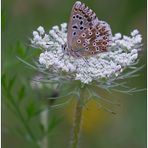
[67,1,98,50]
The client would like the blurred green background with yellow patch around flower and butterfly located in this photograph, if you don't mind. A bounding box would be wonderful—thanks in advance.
[1,0,147,148]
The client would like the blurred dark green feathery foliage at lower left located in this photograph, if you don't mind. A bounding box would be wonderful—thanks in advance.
[2,69,61,146]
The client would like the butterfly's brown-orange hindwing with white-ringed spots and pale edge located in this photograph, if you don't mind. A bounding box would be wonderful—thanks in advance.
[76,21,112,56]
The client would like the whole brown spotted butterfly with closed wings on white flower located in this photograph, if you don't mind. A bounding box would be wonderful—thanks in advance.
[63,1,112,57]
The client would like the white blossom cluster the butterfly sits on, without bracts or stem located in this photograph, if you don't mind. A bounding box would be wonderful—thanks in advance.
[31,23,142,83]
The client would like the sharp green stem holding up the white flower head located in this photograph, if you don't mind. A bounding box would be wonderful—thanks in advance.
[71,93,83,148]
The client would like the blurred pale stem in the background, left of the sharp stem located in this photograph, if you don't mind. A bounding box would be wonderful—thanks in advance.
[40,109,49,148]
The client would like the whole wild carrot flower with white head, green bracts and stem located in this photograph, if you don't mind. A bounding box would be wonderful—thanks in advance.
[21,23,143,147]
